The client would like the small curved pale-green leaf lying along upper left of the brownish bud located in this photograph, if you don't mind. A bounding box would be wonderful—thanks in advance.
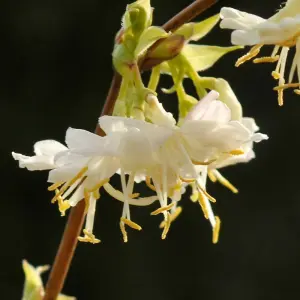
[134,26,168,58]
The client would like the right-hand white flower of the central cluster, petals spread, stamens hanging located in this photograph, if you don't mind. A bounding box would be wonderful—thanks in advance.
[100,91,264,241]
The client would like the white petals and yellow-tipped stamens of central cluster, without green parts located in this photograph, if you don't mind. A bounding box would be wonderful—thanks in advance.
[13,91,267,243]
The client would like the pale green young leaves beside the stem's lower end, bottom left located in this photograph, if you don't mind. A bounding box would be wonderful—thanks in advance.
[22,259,76,300]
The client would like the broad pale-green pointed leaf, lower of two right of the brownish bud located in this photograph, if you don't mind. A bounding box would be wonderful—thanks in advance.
[182,45,242,72]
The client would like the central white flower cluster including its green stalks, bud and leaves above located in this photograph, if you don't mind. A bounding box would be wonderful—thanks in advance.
[12,0,270,244]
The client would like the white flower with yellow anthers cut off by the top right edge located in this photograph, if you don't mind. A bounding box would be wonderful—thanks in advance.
[220,0,300,105]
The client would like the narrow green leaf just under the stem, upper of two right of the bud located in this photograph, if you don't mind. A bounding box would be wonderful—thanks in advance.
[175,14,220,41]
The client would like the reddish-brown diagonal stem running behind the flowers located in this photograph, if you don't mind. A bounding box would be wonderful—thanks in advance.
[43,0,217,300]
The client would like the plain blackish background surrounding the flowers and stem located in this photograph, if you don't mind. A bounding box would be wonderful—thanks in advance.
[0,0,300,300]
